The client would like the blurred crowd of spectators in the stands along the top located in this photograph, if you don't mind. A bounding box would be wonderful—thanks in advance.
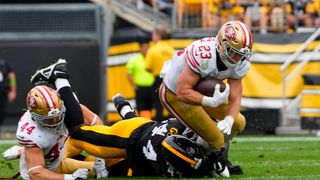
[127,0,320,33]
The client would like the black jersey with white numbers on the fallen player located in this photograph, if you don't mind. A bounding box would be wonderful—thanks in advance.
[128,119,187,177]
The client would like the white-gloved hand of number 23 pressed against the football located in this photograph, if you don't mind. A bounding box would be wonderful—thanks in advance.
[202,84,230,107]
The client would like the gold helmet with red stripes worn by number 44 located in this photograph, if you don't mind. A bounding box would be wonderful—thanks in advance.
[27,85,66,131]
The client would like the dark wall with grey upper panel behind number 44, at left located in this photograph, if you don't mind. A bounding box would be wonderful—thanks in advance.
[0,3,109,132]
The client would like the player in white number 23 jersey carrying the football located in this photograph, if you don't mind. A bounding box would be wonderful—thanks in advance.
[159,21,252,174]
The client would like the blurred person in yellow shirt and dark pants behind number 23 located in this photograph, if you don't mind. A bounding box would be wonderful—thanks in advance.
[146,27,175,121]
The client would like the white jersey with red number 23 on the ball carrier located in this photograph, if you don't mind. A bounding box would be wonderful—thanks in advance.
[161,37,250,92]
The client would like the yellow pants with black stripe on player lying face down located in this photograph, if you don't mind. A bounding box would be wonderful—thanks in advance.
[69,117,152,159]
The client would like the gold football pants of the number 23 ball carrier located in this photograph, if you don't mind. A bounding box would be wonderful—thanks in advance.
[159,84,246,149]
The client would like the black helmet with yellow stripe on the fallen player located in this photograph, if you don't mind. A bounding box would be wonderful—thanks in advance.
[161,135,208,177]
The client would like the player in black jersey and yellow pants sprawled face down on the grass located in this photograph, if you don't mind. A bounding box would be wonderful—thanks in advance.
[31,60,229,177]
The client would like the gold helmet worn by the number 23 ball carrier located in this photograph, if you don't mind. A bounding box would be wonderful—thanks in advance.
[217,21,252,68]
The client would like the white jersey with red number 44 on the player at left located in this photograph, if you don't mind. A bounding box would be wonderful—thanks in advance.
[16,111,68,179]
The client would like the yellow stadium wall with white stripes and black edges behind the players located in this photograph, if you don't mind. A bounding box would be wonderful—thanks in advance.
[106,32,320,134]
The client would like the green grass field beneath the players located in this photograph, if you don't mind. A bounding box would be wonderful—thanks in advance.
[0,136,320,180]
